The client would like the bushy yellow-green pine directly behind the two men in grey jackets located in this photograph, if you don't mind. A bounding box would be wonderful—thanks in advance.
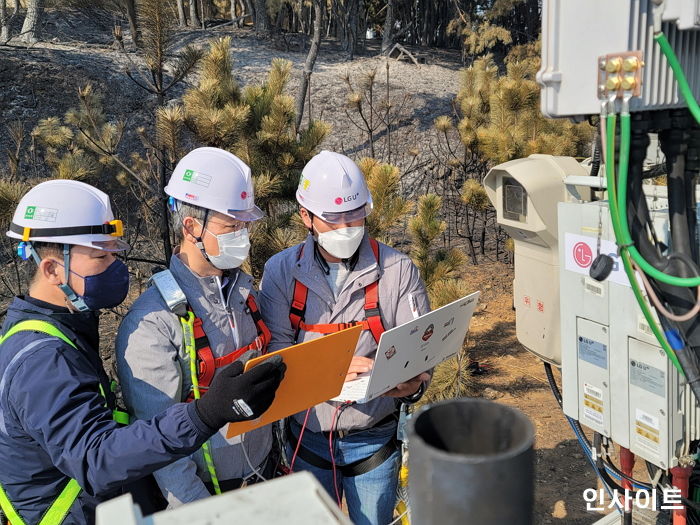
[182,37,330,277]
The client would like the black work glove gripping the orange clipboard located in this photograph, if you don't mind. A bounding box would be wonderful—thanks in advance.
[194,356,287,429]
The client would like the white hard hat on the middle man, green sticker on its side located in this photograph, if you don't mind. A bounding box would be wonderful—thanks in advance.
[165,148,265,221]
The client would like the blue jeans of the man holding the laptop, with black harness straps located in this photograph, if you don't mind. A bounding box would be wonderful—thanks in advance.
[287,422,401,525]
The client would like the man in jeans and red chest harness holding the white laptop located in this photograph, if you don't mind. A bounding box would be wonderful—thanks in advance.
[260,151,430,524]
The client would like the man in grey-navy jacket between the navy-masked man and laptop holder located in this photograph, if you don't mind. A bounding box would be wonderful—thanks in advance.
[116,147,277,507]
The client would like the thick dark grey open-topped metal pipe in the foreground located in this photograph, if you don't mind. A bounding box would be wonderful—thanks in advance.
[408,398,535,525]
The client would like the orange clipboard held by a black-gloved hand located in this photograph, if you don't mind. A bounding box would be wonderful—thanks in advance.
[226,325,362,438]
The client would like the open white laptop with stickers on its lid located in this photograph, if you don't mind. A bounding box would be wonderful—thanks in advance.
[331,292,481,403]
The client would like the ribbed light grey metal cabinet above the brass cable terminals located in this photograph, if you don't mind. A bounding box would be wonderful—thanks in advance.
[537,0,700,117]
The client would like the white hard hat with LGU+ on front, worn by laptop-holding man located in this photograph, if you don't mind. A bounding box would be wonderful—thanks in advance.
[297,151,372,224]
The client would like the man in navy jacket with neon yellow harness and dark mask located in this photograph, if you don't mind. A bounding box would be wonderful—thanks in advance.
[0,180,284,525]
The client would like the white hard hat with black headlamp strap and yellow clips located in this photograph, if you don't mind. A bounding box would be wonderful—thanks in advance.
[7,179,129,252]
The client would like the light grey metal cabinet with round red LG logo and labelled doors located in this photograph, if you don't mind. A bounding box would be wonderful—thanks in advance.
[559,201,700,468]
